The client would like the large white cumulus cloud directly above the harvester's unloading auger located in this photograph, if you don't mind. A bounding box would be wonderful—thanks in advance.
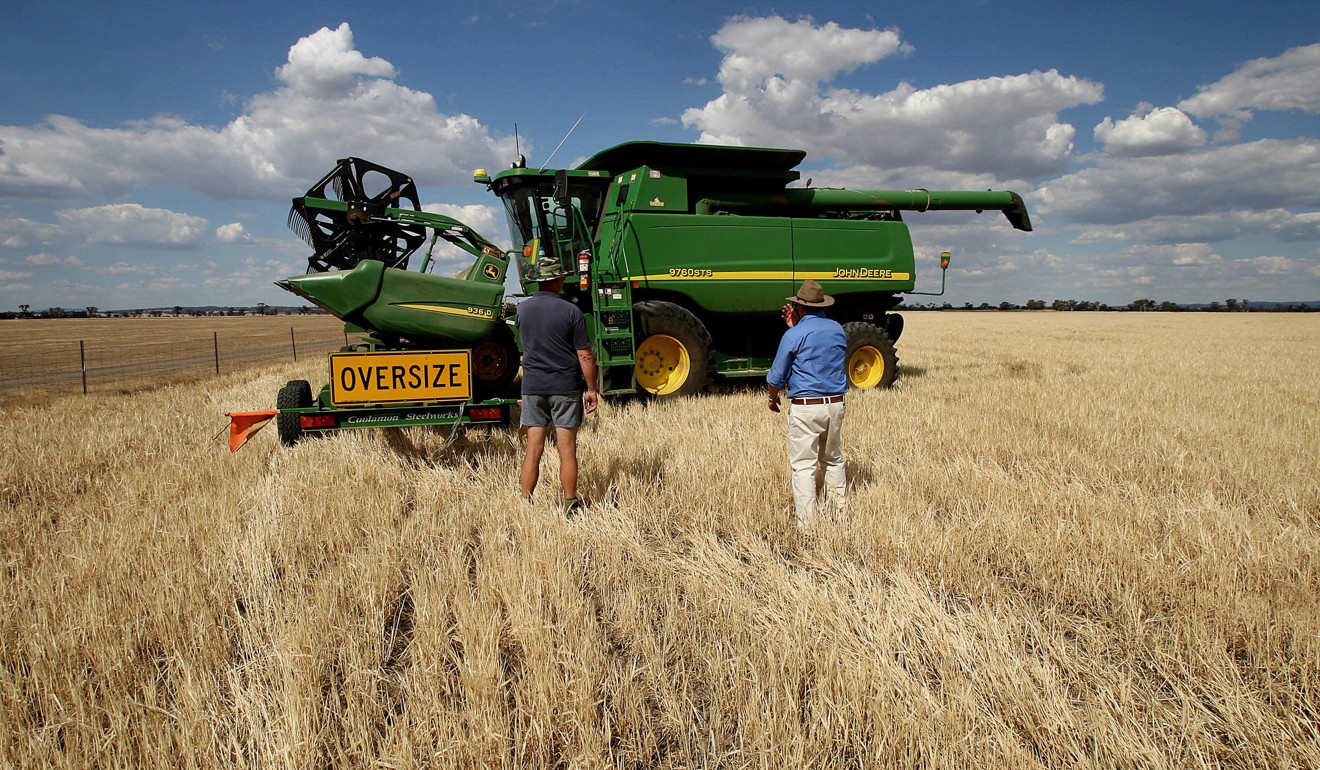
[682,17,1104,178]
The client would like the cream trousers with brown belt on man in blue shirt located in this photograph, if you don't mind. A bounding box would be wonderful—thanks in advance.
[788,402,847,531]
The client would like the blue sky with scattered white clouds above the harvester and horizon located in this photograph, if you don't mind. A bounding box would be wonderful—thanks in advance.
[0,0,1320,310]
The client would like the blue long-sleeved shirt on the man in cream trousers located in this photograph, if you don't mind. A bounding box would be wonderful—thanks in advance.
[766,310,847,399]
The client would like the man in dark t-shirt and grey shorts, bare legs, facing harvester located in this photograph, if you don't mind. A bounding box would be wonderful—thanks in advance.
[517,259,598,516]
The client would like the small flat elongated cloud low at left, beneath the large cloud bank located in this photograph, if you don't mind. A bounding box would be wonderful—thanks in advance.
[55,203,207,248]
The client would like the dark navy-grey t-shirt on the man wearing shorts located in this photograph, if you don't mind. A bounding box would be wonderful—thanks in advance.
[517,292,591,396]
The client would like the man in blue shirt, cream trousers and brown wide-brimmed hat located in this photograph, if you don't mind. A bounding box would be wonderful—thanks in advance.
[766,279,847,532]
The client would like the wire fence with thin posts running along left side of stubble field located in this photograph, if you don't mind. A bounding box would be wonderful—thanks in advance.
[0,326,348,395]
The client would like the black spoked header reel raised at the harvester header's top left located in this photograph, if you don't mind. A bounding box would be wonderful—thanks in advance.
[289,157,426,273]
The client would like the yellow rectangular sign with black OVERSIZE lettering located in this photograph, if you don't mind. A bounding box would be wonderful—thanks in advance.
[330,350,473,405]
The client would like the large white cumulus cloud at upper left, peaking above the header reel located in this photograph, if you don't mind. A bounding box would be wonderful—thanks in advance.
[0,24,513,199]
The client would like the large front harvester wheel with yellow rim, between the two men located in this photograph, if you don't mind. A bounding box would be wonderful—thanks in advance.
[632,301,715,399]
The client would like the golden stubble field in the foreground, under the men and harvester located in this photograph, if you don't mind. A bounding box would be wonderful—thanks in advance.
[0,313,1320,770]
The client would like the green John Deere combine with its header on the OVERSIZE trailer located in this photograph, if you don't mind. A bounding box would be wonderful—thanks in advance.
[230,141,1031,450]
